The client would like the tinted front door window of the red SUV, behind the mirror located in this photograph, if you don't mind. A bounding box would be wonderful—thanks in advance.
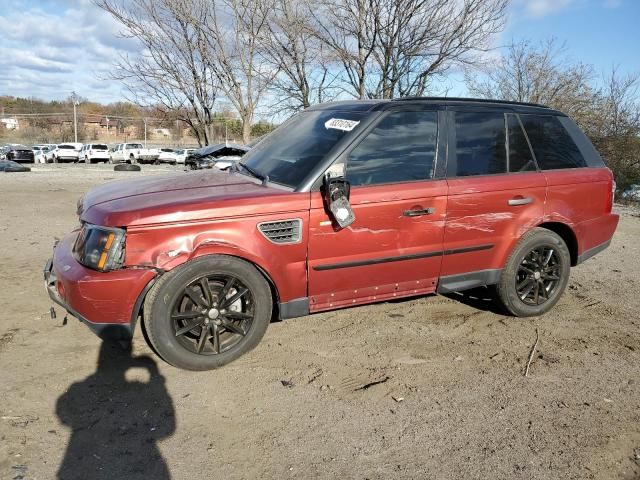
[346,111,438,185]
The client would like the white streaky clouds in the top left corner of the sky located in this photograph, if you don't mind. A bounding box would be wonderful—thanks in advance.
[0,0,139,102]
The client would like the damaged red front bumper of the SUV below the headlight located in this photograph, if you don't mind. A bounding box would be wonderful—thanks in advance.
[44,232,156,338]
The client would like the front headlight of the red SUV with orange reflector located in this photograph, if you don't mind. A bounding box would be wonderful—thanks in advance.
[73,223,125,272]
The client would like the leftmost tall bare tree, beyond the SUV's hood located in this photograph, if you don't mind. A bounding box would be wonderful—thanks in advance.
[96,0,219,145]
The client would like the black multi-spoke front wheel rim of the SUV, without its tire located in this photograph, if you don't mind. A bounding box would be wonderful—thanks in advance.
[171,275,254,355]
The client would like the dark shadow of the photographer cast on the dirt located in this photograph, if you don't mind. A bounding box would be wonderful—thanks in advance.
[56,341,176,480]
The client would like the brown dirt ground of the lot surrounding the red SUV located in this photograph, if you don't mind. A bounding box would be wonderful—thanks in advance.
[0,165,640,480]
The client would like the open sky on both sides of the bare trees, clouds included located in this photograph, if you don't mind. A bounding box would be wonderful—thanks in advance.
[0,0,640,102]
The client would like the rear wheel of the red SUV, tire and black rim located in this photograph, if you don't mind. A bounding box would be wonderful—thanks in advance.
[496,228,571,317]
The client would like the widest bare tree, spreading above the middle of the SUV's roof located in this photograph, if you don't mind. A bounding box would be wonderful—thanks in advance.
[310,0,509,98]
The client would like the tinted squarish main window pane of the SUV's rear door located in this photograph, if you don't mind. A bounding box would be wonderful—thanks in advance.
[455,112,507,177]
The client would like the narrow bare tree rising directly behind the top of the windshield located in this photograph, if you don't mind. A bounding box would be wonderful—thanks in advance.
[262,0,335,113]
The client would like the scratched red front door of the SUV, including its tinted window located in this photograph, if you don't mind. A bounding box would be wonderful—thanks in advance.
[308,110,447,311]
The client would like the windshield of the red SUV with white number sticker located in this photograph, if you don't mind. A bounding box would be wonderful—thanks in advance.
[242,110,364,188]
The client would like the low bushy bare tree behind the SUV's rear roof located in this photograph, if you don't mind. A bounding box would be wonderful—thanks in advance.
[466,39,597,123]
